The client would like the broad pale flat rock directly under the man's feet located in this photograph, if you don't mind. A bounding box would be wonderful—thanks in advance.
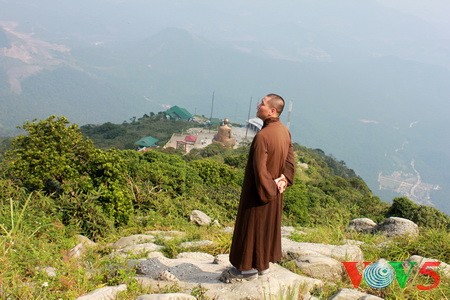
[136,256,323,300]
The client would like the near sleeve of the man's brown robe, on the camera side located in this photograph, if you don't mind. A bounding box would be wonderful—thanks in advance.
[253,136,278,203]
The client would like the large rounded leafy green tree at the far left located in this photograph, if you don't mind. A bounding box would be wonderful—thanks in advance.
[5,116,95,193]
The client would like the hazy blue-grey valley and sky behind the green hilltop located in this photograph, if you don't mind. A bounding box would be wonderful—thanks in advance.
[0,0,450,214]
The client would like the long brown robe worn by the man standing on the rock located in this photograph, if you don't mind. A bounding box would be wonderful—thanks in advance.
[230,118,295,271]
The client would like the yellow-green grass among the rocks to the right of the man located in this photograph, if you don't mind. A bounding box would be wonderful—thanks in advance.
[283,227,450,300]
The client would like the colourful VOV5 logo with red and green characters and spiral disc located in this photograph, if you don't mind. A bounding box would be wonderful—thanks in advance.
[342,259,441,291]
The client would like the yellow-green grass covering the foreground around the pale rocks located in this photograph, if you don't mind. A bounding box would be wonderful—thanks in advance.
[0,193,450,299]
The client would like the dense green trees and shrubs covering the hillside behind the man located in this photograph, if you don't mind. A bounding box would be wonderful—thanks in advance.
[0,115,450,299]
